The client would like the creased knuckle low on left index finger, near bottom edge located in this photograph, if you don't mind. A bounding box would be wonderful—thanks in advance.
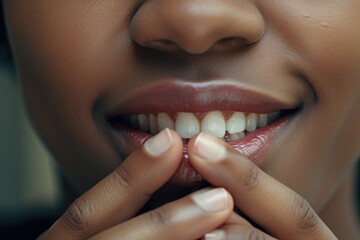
[63,197,91,235]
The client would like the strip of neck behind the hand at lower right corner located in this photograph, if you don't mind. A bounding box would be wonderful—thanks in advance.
[320,168,360,239]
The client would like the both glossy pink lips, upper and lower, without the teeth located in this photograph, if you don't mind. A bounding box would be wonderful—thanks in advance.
[107,84,297,186]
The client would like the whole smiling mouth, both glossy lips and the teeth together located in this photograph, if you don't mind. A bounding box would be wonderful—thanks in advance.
[106,81,301,186]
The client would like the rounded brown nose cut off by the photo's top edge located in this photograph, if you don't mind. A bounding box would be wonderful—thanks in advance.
[130,0,265,54]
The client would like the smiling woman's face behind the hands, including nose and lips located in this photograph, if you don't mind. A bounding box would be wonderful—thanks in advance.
[4,0,360,210]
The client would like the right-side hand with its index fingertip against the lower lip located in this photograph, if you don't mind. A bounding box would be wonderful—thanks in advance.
[188,133,337,240]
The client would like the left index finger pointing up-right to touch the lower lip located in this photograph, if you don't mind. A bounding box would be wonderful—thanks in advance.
[41,129,182,240]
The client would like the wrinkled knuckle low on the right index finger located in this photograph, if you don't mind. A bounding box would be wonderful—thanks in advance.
[294,194,319,233]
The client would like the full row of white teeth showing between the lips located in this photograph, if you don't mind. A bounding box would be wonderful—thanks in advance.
[129,111,280,141]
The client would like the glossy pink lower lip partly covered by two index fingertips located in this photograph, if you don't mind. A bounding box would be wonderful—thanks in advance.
[112,117,289,186]
